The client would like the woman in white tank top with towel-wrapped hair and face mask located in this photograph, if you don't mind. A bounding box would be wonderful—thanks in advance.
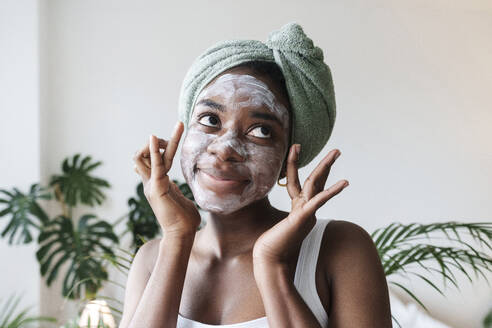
[120,23,391,328]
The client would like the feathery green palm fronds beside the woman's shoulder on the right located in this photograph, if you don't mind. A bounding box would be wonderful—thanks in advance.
[371,221,492,310]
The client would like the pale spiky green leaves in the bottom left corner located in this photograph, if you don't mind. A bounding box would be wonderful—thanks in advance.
[0,294,56,328]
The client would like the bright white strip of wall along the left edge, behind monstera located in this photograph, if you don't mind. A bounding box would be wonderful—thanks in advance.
[0,0,40,315]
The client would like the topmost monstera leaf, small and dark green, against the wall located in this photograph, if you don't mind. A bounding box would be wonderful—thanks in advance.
[50,154,110,207]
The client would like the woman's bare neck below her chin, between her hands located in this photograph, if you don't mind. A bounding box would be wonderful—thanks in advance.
[197,197,288,260]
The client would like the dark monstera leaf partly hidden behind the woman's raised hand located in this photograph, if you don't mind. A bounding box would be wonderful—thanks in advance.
[127,180,199,250]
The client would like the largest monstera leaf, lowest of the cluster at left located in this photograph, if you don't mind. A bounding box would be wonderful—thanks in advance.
[36,214,119,299]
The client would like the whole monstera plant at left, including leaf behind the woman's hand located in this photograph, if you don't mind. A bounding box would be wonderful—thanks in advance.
[0,154,199,308]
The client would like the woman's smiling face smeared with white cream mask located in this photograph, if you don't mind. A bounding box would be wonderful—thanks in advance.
[181,69,289,214]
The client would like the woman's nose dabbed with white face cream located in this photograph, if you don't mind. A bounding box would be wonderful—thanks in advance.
[207,131,247,162]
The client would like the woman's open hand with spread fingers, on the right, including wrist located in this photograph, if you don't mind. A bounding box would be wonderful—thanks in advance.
[253,144,348,266]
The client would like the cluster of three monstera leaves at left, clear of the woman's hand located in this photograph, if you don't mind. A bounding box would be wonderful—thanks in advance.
[0,154,118,298]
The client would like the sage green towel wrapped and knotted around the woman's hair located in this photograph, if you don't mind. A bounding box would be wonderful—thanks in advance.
[179,22,336,167]
